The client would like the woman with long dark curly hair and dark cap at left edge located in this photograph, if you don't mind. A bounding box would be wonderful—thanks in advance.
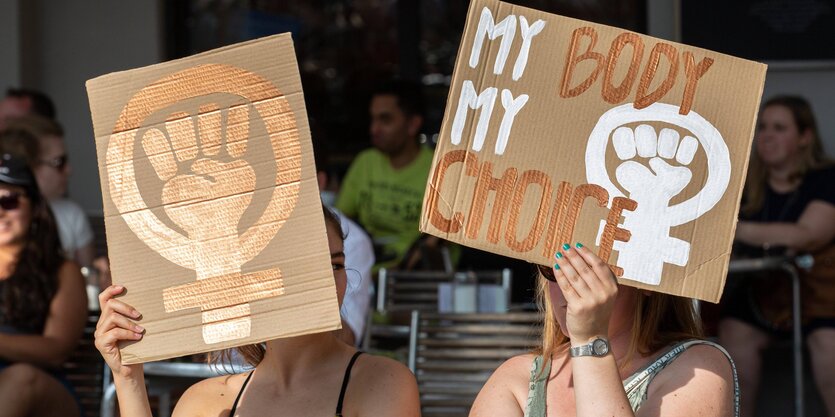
[0,154,87,417]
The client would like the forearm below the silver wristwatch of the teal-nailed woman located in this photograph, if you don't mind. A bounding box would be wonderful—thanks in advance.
[571,353,635,417]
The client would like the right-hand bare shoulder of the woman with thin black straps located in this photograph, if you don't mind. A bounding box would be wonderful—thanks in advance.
[347,354,420,417]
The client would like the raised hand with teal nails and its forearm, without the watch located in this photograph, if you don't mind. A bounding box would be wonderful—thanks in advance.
[554,245,634,417]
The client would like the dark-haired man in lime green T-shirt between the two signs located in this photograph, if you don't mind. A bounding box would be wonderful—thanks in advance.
[336,81,434,270]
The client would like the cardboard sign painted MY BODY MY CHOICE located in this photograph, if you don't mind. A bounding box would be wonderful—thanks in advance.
[421,0,766,302]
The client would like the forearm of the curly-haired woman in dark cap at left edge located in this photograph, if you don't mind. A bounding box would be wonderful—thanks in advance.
[0,333,74,368]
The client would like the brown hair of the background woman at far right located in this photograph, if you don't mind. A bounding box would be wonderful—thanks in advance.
[742,96,832,216]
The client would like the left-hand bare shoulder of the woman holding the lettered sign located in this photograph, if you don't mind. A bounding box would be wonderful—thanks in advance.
[470,354,536,417]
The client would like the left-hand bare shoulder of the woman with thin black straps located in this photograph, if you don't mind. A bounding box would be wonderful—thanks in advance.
[173,373,249,417]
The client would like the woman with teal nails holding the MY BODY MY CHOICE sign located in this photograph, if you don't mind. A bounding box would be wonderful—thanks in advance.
[470,243,739,417]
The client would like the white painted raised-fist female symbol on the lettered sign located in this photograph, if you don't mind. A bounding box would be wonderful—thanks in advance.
[586,103,731,285]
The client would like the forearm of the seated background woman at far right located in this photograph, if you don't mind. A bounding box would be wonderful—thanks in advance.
[736,222,825,250]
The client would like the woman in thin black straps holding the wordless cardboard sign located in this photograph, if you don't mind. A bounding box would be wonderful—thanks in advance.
[96,209,420,417]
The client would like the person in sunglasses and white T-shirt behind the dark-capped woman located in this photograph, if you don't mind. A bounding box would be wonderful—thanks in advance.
[0,116,96,266]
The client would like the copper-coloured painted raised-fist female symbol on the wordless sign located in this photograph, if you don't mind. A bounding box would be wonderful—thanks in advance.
[106,64,301,344]
